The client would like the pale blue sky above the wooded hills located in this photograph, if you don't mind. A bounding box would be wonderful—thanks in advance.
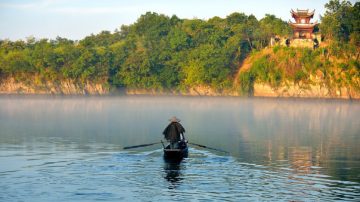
[0,0,357,41]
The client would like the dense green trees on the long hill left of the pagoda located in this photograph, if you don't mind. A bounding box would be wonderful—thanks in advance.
[0,12,288,90]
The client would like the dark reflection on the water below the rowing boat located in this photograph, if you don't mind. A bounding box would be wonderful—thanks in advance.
[164,158,185,189]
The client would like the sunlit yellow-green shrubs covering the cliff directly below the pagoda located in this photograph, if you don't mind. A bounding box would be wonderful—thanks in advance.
[239,43,360,95]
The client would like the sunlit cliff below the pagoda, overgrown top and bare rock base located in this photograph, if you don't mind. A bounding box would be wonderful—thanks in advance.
[234,46,360,99]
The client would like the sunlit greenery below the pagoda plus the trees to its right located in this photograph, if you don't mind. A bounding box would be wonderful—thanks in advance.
[238,1,360,97]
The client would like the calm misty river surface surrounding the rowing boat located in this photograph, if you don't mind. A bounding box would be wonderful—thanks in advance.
[0,96,360,201]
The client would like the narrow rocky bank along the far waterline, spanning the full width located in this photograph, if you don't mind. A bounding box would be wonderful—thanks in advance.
[0,79,360,100]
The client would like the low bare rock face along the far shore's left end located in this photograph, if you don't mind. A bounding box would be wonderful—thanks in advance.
[0,78,109,95]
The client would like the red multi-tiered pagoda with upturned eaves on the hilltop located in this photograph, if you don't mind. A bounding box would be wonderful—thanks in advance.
[289,9,318,39]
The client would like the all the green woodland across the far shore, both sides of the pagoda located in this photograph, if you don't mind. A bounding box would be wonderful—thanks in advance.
[0,0,360,94]
